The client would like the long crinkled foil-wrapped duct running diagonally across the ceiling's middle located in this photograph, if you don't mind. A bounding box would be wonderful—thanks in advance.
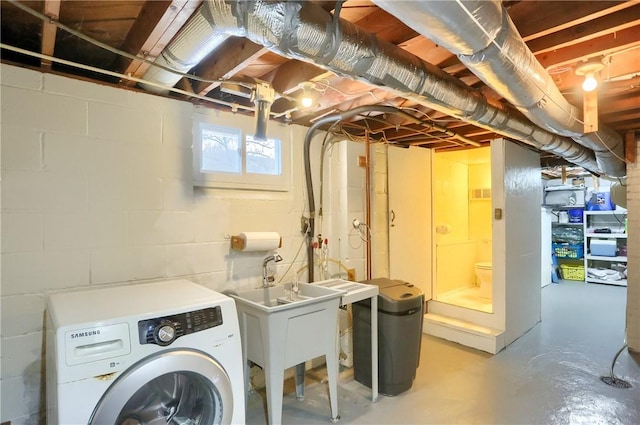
[140,0,604,174]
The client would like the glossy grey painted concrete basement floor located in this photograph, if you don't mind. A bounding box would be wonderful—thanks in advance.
[246,281,640,425]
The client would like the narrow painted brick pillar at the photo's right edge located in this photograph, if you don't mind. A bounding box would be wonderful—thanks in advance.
[627,140,640,355]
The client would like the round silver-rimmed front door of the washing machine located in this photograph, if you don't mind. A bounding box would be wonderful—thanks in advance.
[89,349,233,425]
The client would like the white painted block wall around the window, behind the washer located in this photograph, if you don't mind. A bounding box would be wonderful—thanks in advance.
[0,65,363,425]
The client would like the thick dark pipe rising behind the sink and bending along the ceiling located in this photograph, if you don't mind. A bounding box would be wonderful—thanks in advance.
[303,105,412,283]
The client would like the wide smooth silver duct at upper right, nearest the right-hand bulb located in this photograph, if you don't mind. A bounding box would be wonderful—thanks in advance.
[374,0,626,177]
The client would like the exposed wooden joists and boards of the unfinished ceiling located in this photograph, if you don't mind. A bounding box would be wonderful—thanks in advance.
[0,0,640,171]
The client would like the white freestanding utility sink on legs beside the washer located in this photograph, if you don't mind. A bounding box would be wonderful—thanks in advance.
[228,283,346,424]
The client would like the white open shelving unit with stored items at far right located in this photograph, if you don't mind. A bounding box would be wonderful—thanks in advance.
[582,210,627,286]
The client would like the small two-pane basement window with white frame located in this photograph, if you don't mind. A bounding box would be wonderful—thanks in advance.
[193,122,290,191]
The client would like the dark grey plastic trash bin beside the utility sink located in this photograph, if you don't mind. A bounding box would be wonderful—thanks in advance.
[353,278,424,396]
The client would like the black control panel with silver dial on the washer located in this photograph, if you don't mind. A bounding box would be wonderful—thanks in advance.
[138,306,222,346]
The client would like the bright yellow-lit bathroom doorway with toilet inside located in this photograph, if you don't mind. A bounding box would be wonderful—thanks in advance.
[432,147,493,313]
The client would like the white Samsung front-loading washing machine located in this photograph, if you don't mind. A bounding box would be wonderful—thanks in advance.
[46,280,245,425]
